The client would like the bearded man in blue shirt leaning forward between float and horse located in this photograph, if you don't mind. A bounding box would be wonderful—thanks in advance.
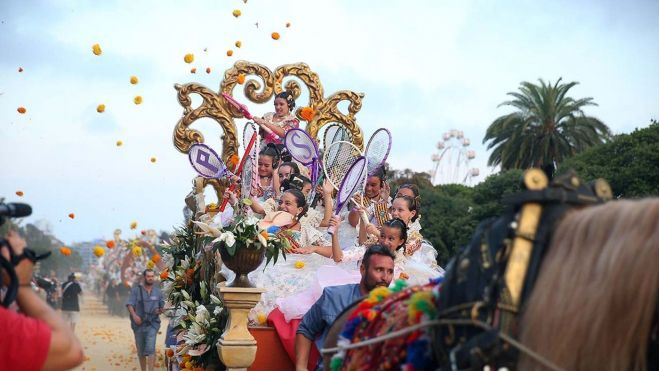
[295,245,395,371]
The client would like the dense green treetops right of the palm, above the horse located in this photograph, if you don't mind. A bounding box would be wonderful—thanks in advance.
[558,120,659,198]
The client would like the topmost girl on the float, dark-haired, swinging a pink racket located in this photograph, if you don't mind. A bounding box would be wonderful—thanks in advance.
[253,91,300,148]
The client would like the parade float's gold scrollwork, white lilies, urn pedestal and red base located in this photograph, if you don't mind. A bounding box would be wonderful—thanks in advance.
[160,61,364,370]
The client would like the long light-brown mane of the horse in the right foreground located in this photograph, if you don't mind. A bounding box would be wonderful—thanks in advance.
[518,198,659,370]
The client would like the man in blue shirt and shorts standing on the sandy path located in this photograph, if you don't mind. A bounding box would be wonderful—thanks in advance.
[126,269,165,371]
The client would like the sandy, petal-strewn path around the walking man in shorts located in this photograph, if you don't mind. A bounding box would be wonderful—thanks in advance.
[75,295,167,371]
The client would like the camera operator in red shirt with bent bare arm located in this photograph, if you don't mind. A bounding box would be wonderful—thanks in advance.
[0,231,84,370]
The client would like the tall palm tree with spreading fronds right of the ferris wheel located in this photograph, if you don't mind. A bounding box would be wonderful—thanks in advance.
[483,78,611,170]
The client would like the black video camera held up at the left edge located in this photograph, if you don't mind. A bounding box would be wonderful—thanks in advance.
[0,198,51,308]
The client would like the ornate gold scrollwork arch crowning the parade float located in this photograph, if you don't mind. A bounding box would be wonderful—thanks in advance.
[173,61,364,200]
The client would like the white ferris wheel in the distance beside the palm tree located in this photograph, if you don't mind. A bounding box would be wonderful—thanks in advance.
[430,129,480,185]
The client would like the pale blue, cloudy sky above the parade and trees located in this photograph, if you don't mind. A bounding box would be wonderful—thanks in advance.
[0,0,659,244]
